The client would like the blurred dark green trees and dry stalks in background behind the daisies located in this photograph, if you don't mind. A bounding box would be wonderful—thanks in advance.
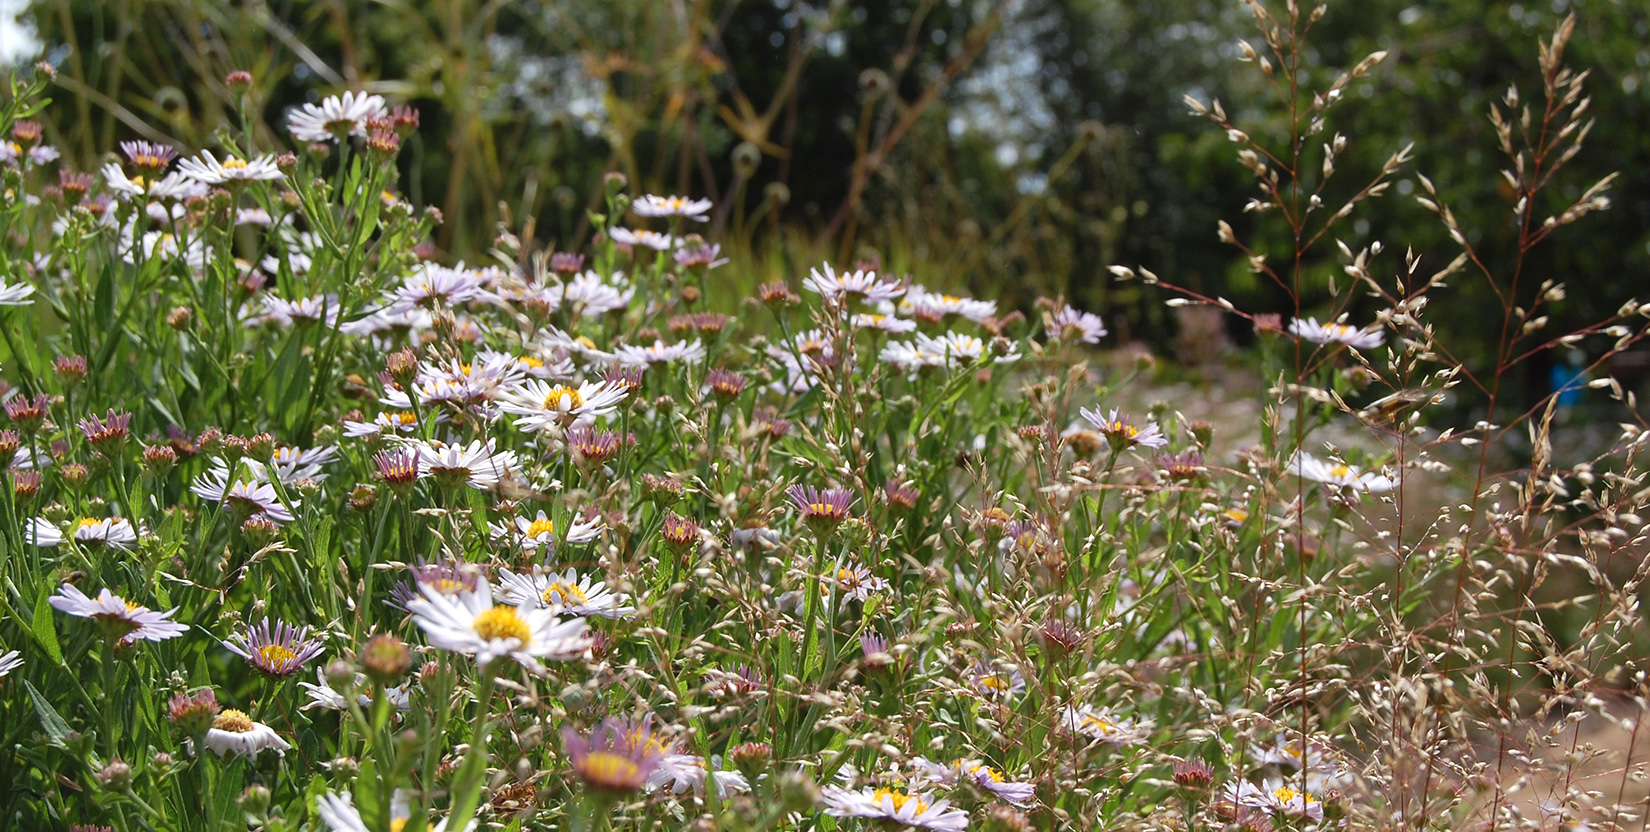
[12,0,1650,399]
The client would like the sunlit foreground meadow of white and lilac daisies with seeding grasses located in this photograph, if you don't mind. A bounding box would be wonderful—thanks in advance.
[0,3,1650,832]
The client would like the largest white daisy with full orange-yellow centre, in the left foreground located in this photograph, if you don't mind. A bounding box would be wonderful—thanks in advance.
[408,581,591,670]
